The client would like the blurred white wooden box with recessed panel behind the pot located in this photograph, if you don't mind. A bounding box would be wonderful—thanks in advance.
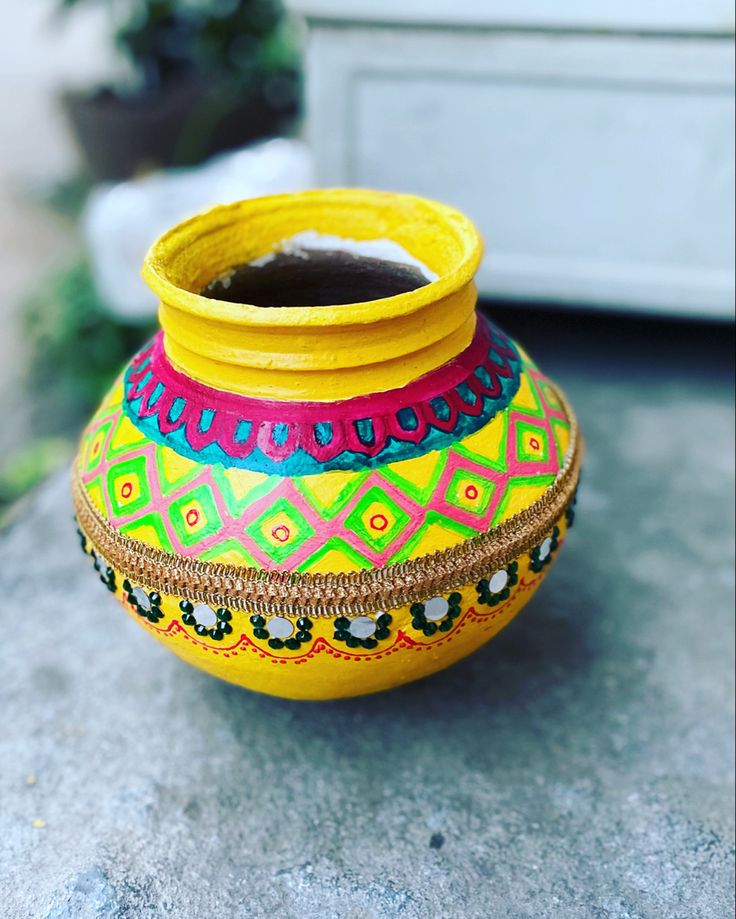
[291,0,734,316]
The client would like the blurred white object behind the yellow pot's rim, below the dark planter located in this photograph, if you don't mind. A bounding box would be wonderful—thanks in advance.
[82,139,313,322]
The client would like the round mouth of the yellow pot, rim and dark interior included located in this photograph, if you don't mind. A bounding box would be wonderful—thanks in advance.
[143,189,481,326]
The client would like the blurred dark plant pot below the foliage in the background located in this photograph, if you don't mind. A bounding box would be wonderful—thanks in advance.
[61,73,298,181]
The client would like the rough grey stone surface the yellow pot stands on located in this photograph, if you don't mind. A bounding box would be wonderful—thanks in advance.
[0,313,734,919]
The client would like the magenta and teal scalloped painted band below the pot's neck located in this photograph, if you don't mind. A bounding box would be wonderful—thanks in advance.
[124,320,522,476]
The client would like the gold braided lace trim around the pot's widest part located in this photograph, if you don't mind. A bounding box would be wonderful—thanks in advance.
[72,390,583,617]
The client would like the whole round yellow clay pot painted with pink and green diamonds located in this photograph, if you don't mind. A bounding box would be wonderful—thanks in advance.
[73,190,581,699]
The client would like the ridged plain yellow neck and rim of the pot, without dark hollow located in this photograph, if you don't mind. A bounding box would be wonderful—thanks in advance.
[143,189,481,401]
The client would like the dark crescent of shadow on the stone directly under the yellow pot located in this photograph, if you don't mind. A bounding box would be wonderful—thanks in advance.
[208,579,602,756]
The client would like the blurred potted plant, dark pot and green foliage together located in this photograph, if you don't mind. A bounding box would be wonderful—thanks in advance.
[59,0,299,179]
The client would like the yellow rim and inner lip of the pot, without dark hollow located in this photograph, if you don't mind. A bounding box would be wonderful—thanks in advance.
[142,188,483,328]
